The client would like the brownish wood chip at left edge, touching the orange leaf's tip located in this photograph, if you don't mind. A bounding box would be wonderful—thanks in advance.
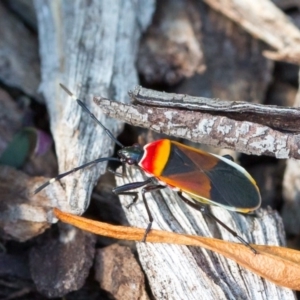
[0,166,59,242]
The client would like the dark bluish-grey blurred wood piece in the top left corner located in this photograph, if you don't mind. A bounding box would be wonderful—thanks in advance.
[0,1,42,101]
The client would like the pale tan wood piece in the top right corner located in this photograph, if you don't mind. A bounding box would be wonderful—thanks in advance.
[204,0,300,64]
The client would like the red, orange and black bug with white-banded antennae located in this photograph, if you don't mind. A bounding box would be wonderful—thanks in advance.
[34,84,261,253]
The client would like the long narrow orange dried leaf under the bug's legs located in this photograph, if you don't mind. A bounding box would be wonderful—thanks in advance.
[54,209,300,290]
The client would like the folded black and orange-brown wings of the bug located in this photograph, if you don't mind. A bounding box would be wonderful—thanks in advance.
[159,142,261,212]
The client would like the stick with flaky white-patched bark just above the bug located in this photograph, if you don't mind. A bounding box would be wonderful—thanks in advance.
[94,97,300,159]
